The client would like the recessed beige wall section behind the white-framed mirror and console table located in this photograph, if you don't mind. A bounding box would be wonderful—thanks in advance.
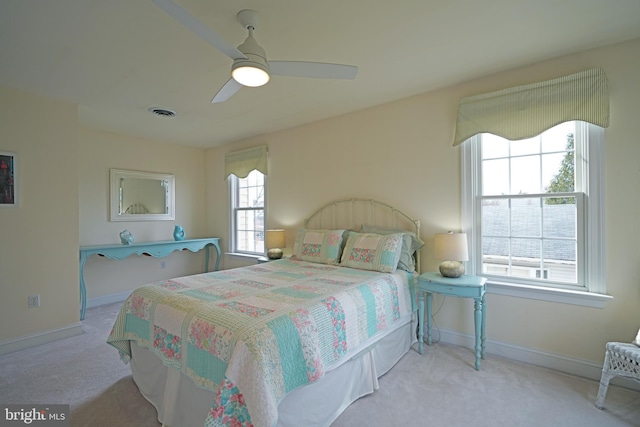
[78,129,208,303]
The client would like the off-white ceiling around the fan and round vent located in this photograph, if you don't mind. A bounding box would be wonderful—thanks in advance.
[0,0,640,147]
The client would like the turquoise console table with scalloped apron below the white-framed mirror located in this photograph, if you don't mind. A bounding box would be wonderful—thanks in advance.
[80,237,221,320]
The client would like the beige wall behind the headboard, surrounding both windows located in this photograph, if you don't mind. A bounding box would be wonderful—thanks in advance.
[207,40,640,363]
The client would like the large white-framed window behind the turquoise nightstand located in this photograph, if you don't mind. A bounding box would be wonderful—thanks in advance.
[462,121,605,302]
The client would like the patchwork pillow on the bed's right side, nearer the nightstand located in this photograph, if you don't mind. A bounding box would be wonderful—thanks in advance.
[340,231,403,273]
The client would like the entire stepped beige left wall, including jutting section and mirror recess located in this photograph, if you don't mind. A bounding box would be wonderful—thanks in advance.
[0,87,207,354]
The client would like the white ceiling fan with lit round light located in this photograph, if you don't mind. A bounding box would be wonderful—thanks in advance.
[152,0,358,104]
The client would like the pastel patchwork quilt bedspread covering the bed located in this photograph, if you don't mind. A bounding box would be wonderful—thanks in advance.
[107,260,415,427]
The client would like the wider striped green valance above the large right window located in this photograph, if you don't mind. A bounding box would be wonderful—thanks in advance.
[453,68,609,146]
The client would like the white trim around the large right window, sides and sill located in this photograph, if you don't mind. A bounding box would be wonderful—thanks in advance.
[461,123,613,308]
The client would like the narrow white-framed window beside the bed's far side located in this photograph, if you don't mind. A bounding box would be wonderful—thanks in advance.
[229,170,266,255]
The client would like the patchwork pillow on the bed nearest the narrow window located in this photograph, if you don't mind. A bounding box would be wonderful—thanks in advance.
[292,228,344,265]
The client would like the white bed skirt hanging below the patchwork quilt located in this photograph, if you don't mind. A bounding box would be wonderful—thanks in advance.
[131,319,416,427]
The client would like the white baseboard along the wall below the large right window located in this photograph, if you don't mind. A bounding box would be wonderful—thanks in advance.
[434,329,640,390]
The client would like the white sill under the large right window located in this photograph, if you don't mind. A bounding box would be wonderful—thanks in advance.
[487,281,613,308]
